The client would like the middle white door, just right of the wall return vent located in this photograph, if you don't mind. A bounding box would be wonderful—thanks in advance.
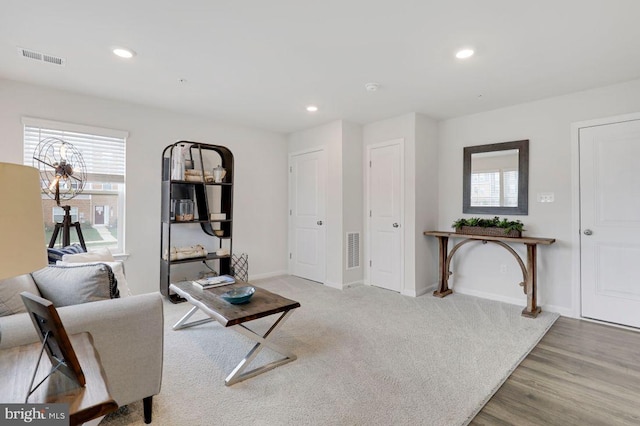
[367,140,403,291]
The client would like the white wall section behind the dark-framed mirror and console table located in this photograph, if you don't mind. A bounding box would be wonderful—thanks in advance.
[434,80,640,315]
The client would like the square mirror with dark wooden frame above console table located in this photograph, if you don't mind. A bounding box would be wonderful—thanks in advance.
[462,140,529,215]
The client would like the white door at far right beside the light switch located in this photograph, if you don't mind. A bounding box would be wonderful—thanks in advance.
[579,120,640,327]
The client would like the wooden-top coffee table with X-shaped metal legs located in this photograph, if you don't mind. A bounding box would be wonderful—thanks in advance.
[169,281,300,386]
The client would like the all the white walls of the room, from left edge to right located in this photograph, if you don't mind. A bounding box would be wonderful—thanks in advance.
[8,72,640,315]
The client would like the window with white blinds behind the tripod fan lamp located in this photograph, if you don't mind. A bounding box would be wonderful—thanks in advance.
[22,117,128,253]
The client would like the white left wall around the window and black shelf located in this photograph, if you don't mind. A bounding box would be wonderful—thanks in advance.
[0,79,287,293]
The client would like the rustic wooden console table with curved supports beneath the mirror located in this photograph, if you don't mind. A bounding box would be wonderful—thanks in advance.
[424,231,556,318]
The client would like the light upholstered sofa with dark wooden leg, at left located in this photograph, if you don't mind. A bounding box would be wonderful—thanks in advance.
[0,267,163,423]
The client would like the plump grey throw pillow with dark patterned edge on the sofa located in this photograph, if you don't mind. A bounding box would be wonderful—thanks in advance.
[31,263,120,307]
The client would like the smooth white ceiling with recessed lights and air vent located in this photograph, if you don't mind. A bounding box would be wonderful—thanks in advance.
[0,0,640,132]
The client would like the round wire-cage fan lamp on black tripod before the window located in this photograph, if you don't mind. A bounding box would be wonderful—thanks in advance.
[33,138,87,251]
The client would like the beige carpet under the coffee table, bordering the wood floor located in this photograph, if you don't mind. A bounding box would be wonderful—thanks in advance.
[100,276,557,426]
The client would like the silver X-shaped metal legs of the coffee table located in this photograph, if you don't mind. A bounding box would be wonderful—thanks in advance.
[173,306,298,386]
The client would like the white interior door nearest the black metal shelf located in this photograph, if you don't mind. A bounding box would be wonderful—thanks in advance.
[289,150,327,283]
